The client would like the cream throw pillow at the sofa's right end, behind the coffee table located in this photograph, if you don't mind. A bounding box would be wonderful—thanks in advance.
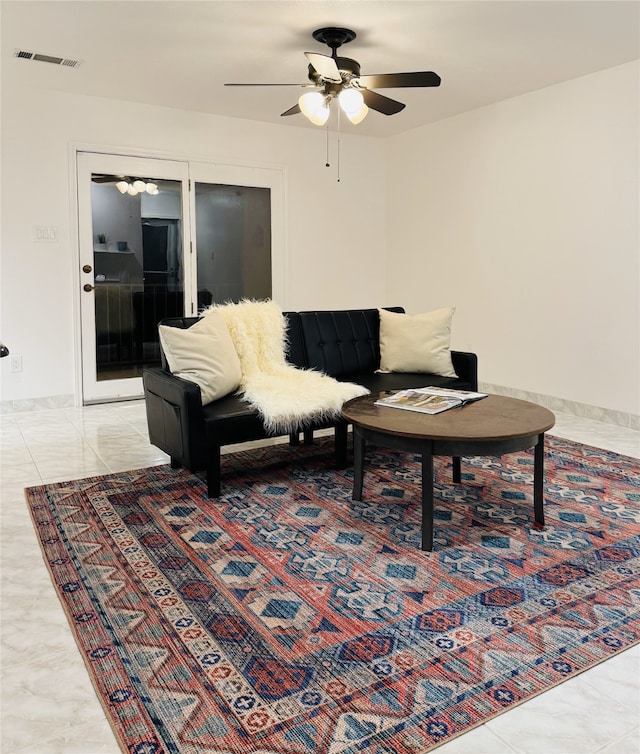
[378,306,457,377]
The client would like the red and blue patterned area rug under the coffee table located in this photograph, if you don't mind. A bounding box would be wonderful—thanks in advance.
[27,437,640,754]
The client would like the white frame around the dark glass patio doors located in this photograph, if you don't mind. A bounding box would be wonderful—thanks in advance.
[68,142,289,406]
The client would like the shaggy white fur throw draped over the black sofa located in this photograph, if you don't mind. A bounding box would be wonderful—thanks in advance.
[202,300,369,434]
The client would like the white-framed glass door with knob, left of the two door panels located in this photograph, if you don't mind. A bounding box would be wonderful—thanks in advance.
[78,154,191,402]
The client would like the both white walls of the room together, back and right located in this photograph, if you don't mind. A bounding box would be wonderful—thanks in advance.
[0,64,640,414]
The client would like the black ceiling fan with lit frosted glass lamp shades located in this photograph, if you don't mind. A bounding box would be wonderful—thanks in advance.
[225,26,440,126]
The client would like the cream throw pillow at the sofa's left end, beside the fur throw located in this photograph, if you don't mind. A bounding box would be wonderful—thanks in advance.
[158,312,242,406]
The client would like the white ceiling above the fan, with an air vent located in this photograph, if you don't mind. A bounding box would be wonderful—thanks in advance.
[0,0,640,136]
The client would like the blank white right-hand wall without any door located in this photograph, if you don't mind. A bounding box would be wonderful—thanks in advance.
[387,63,640,415]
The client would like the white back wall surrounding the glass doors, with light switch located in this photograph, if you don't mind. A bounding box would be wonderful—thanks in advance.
[0,87,386,401]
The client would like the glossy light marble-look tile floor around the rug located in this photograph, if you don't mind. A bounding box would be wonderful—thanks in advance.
[0,401,640,754]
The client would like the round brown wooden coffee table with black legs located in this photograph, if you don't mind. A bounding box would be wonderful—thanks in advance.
[342,393,555,552]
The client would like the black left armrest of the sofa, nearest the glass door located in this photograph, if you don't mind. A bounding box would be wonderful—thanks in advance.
[142,368,205,470]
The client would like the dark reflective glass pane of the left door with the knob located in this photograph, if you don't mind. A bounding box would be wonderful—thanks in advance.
[91,173,189,382]
